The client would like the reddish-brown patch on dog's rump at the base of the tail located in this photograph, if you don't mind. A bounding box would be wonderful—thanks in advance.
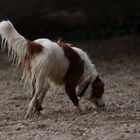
[20,40,43,71]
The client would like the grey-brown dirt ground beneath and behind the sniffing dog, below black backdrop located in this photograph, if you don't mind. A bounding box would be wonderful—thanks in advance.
[0,36,140,140]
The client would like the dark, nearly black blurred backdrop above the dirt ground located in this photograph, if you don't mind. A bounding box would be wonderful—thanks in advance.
[0,0,140,40]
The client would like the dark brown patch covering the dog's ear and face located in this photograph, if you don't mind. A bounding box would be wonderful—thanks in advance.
[91,76,104,98]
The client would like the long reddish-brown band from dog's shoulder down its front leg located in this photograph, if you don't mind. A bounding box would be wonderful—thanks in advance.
[57,41,84,106]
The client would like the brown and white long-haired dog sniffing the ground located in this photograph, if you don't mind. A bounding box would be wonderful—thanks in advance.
[0,21,105,118]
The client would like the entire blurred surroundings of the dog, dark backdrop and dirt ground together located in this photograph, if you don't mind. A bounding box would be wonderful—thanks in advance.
[0,0,140,140]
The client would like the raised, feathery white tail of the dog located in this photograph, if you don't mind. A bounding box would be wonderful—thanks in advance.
[0,20,27,63]
